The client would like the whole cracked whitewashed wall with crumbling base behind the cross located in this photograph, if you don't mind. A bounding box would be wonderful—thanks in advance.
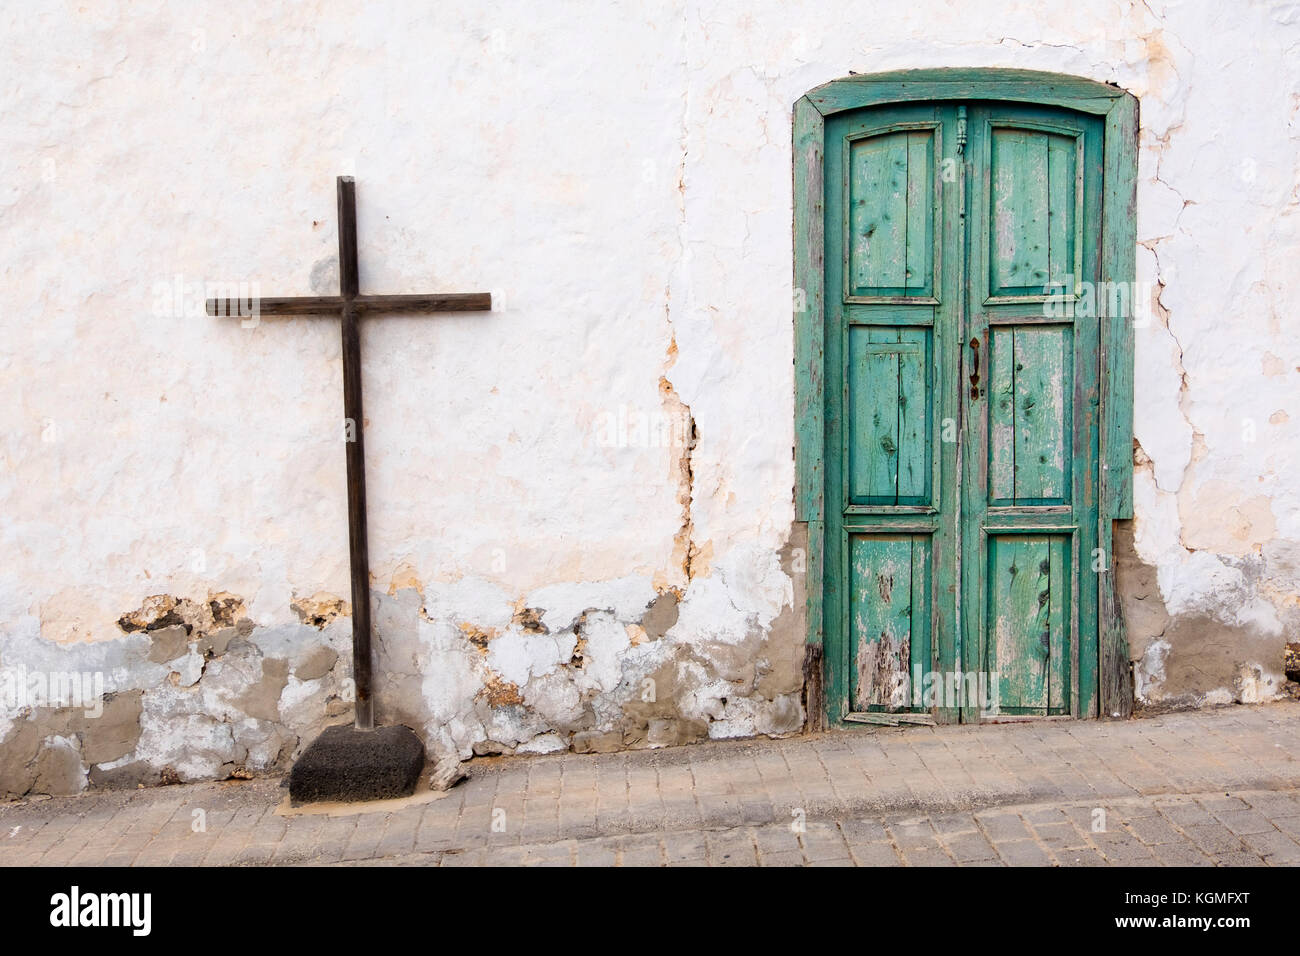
[0,0,1300,791]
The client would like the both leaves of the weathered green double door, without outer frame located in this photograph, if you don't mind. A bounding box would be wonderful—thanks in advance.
[824,101,1102,723]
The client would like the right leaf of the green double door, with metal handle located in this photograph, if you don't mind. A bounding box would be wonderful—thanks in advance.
[962,103,1102,719]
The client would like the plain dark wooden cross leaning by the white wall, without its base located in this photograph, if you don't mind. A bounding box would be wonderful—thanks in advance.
[207,176,491,730]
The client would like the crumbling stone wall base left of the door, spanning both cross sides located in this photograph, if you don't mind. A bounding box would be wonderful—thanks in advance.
[0,528,803,796]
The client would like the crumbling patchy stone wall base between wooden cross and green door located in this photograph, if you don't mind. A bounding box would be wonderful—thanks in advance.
[374,538,803,757]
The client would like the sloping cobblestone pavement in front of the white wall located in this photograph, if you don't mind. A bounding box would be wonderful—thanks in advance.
[0,701,1300,866]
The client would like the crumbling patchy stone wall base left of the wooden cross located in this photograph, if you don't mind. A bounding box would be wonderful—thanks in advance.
[0,594,351,797]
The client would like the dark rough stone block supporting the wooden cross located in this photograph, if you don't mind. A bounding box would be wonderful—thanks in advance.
[289,724,424,804]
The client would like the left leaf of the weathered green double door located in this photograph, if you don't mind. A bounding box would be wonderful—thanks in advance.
[813,104,957,723]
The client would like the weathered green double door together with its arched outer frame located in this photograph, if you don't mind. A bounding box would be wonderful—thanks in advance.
[794,69,1138,724]
